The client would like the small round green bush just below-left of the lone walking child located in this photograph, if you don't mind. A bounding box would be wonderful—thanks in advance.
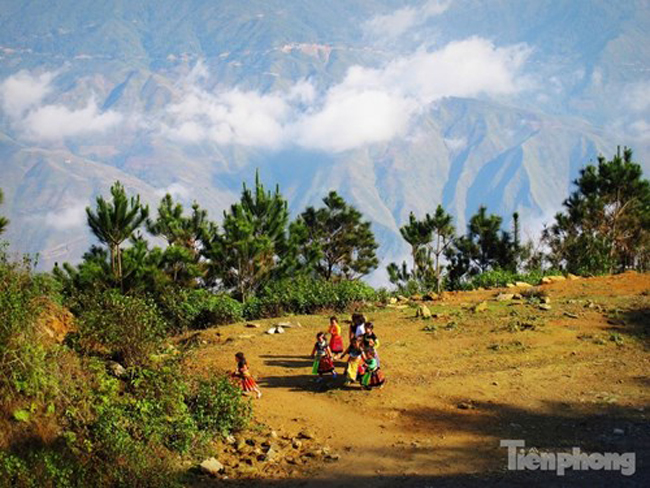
[188,377,252,436]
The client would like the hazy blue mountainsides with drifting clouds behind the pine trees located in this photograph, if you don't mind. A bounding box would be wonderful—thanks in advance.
[0,0,650,283]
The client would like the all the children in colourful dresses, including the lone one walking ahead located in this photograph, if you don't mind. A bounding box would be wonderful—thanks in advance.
[231,313,386,398]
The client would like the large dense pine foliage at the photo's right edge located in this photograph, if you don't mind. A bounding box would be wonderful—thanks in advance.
[543,149,650,275]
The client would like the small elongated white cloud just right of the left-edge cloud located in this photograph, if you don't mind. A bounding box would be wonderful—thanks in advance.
[21,100,122,141]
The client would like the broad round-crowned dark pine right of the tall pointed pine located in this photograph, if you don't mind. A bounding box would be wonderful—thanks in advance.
[292,191,379,280]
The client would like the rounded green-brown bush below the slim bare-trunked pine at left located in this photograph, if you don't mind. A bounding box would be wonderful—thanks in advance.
[78,290,166,366]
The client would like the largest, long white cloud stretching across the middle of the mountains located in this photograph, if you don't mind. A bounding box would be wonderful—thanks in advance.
[163,37,529,152]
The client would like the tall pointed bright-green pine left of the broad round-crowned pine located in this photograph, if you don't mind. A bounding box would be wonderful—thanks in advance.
[204,173,289,300]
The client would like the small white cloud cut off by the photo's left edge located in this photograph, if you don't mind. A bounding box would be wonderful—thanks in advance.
[0,70,56,118]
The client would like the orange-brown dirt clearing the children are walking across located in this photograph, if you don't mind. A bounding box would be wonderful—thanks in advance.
[188,274,650,486]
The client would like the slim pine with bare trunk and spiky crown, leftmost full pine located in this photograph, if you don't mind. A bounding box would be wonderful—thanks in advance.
[86,181,149,282]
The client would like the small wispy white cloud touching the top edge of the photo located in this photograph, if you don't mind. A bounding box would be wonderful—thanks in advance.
[363,0,450,38]
